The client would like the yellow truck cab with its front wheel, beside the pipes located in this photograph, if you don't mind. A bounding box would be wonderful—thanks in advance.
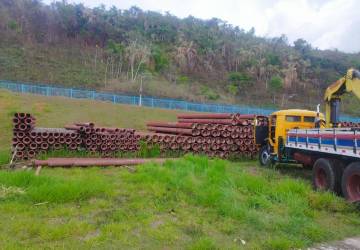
[259,109,324,165]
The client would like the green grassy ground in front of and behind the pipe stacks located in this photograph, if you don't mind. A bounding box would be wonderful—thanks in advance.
[0,91,360,249]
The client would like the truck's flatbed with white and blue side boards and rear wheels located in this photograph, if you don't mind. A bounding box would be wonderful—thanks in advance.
[284,128,360,202]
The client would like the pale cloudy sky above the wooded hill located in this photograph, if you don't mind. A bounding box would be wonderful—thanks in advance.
[44,0,360,52]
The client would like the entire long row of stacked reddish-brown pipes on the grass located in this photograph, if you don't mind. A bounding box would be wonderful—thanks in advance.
[12,113,268,160]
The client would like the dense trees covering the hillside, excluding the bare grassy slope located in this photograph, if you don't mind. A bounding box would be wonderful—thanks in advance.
[0,0,360,104]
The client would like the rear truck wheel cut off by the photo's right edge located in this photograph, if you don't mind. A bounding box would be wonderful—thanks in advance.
[341,162,360,202]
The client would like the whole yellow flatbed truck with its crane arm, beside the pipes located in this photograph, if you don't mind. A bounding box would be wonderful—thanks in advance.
[255,69,360,202]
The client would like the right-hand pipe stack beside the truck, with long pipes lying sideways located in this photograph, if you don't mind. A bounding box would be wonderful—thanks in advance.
[147,114,268,157]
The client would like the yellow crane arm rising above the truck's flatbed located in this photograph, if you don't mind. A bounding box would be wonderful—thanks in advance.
[324,69,360,127]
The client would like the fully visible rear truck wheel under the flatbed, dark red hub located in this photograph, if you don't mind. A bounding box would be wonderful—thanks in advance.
[312,158,341,193]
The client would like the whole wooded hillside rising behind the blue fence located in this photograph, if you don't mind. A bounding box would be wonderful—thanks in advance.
[0,0,360,115]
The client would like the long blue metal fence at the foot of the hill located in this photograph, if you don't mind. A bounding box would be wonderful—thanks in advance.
[0,80,360,122]
